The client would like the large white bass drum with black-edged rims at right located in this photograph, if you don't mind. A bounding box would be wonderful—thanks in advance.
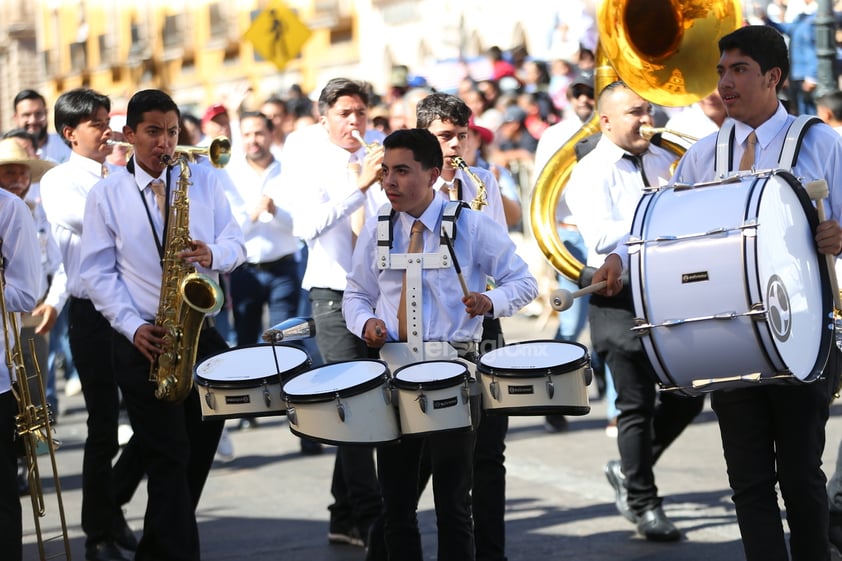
[629,172,832,395]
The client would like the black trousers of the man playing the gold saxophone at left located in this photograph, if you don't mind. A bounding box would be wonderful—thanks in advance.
[112,328,228,561]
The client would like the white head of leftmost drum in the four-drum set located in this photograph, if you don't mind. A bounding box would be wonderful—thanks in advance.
[194,345,310,388]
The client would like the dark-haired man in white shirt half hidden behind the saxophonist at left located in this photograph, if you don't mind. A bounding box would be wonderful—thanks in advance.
[41,88,143,559]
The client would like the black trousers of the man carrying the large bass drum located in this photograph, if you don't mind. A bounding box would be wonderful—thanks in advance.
[711,380,830,561]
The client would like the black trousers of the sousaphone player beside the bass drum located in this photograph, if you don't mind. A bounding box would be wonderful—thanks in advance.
[588,298,704,515]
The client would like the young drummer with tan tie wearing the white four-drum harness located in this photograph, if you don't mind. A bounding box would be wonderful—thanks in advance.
[343,129,538,561]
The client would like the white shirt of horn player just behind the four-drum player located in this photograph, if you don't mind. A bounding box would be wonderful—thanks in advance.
[279,125,388,291]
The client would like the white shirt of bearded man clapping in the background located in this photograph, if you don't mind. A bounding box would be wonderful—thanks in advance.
[224,156,299,263]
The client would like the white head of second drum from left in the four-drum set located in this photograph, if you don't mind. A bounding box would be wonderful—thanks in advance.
[284,360,389,402]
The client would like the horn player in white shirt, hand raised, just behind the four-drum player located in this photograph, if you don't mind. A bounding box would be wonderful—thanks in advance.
[281,78,386,546]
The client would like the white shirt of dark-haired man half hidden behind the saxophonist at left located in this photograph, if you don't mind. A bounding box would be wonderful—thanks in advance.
[41,152,108,298]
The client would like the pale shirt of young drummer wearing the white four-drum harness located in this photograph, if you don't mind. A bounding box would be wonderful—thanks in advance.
[342,197,538,342]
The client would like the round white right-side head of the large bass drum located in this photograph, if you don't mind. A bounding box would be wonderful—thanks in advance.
[756,173,832,381]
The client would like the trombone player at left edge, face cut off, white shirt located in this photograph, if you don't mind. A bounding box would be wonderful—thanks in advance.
[0,190,41,561]
